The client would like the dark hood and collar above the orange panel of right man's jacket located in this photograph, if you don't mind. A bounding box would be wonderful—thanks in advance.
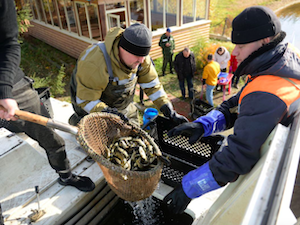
[236,32,300,80]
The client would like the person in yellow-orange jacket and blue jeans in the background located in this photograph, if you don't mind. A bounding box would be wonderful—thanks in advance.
[202,54,220,106]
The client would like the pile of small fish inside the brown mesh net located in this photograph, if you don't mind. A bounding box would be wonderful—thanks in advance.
[106,136,157,171]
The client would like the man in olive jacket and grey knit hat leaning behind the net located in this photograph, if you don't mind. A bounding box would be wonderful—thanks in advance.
[69,23,188,125]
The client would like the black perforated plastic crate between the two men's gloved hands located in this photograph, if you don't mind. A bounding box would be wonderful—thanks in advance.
[150,116,224,187]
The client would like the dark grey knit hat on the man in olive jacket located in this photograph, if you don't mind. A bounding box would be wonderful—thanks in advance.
[119,23,152,56]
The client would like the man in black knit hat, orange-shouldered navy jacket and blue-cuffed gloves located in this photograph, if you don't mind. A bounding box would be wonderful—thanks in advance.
[165,6,300,213]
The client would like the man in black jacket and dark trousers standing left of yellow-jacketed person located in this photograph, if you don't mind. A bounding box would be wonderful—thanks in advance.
[174,48,196,99]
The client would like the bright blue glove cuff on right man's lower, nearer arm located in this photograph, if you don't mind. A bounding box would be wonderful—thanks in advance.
[181,162,221,199]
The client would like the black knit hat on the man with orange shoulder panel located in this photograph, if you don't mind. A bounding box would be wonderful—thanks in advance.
[231,6,281,44]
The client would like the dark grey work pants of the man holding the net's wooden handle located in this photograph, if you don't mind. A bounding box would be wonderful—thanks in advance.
[5,78,70,173]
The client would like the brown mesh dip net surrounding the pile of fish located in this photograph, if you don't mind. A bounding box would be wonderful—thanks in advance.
[77,113,163,202]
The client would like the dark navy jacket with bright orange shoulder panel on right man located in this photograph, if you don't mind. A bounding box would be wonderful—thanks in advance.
[209,34,300,184]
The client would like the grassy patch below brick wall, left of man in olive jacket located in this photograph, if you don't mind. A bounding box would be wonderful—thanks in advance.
[20,37,76,98]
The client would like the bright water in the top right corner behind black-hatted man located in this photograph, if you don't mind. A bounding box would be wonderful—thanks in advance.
[277,3,300,49]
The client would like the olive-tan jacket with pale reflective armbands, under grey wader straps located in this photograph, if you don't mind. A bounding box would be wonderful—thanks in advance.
[76,28,169,112]
